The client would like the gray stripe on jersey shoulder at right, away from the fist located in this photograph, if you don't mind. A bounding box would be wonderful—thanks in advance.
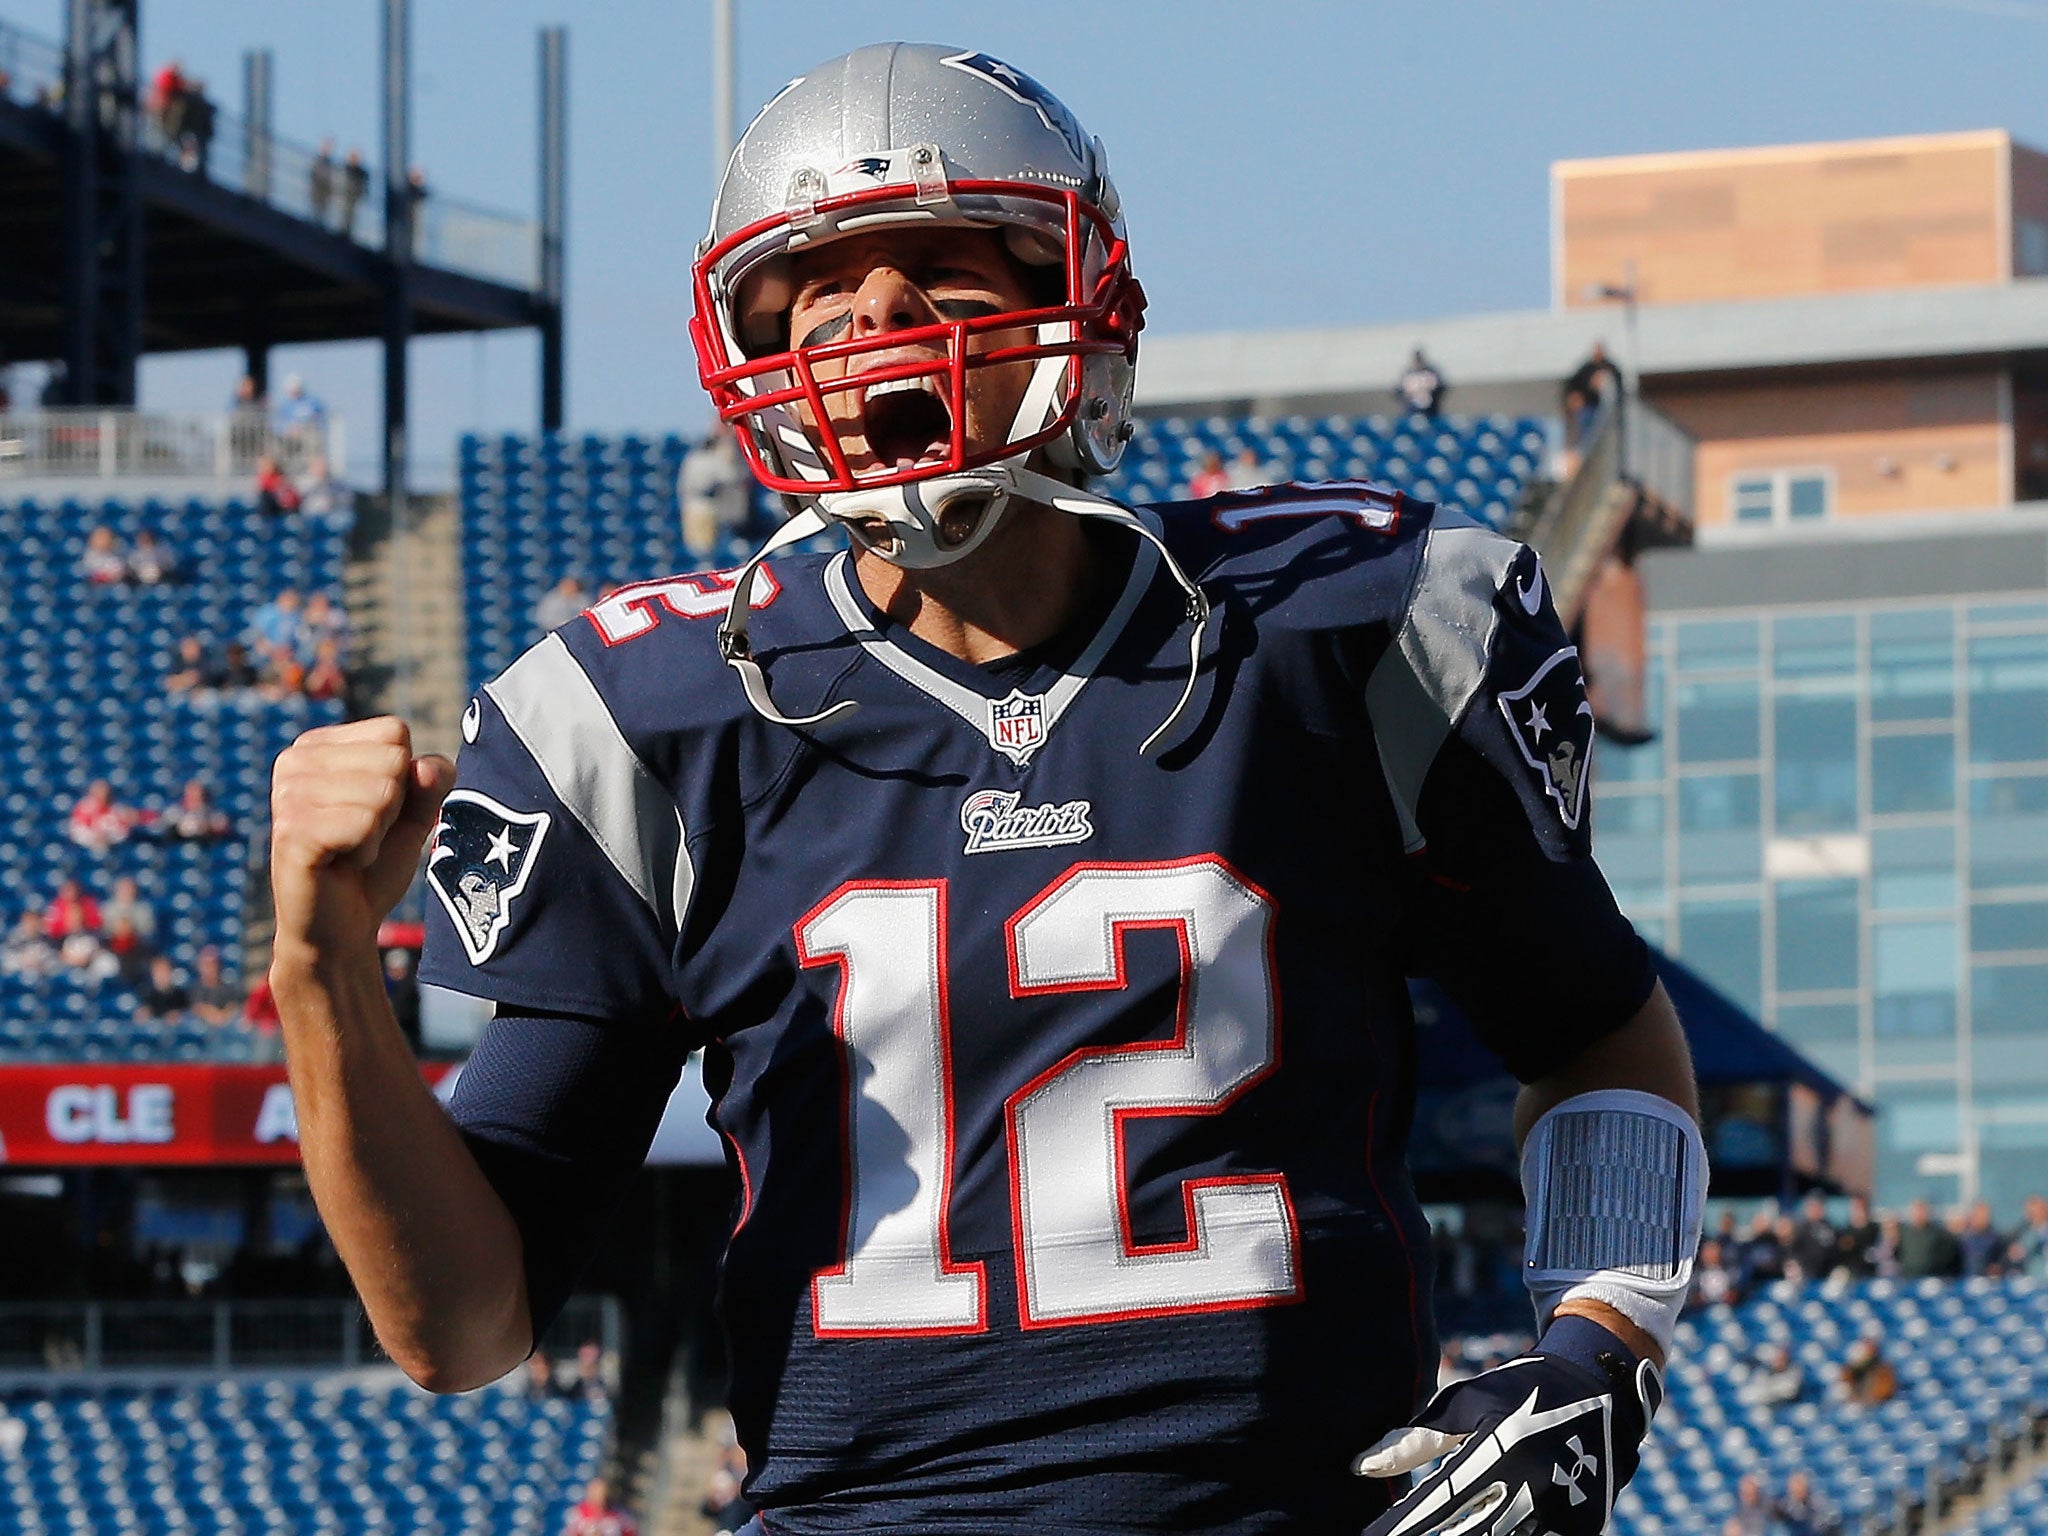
[1366,518,1522,852]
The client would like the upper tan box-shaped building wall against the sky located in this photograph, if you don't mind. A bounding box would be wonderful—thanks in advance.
[1550,131,2007,307]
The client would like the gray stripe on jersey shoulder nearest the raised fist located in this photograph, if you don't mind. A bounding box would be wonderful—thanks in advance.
[483,635,696,932]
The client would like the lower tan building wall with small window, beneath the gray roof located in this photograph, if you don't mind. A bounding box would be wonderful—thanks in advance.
[1651,371,2007,526]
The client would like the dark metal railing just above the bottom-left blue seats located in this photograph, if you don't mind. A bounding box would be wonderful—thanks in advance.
[0,1296,623,1374]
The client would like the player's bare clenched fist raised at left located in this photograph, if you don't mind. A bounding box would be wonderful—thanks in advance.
[270,715,455,961]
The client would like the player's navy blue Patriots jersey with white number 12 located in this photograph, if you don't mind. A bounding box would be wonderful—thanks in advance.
[422,485,1651,1534]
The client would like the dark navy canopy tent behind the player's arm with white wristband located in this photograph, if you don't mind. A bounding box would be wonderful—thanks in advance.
[1409,948,1874,1202]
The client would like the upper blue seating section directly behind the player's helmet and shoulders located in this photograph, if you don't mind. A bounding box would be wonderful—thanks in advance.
[457,416,1548,686]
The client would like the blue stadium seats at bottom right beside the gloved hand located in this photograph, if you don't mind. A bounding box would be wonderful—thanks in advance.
[1614,1278,2048,1536]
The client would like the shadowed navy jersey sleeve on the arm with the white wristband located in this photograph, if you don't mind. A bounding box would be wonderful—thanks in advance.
[1366,520,1655,1081]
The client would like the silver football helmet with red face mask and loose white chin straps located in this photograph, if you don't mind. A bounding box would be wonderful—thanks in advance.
[690,43,1208,761]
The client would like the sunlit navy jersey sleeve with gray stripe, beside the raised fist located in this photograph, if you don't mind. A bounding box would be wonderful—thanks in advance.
[420,635,692,1020]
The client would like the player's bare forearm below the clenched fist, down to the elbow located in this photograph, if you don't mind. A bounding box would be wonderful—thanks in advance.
[270,948,530,1391]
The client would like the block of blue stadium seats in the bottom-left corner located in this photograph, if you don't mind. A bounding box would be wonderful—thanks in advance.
[0,1378,610,1536]
